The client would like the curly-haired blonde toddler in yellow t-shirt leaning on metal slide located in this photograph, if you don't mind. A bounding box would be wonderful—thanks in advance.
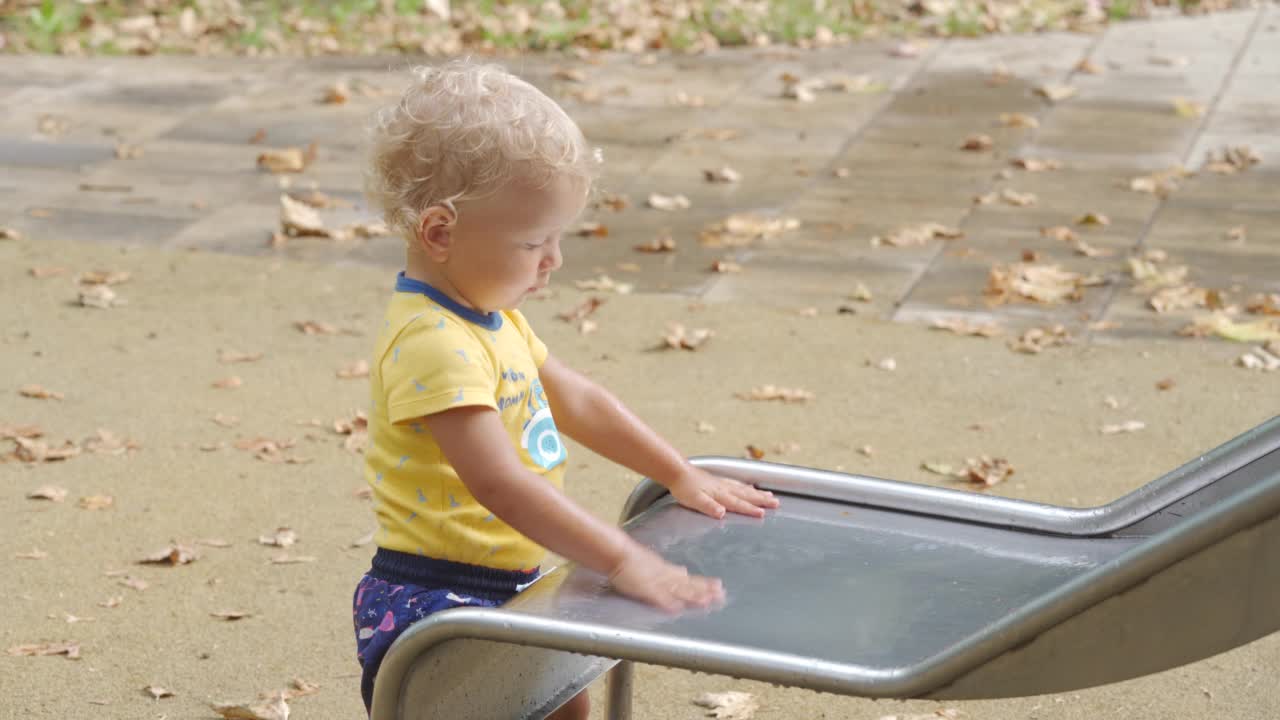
[353,61,778,719]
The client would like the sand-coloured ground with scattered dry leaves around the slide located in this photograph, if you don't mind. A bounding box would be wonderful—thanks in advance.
[0,241,1280,720]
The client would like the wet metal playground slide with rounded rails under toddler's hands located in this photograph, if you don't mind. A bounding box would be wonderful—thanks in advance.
[372,416,1280,720]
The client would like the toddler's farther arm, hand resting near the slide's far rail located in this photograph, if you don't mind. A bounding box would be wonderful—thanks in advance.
[538,355,778,518]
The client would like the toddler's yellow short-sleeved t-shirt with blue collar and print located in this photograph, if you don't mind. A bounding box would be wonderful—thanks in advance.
[365,274,568,570]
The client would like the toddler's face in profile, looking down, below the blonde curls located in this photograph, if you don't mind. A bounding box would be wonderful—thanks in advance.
[448,176,586,311]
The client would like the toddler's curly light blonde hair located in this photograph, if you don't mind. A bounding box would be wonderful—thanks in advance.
[365,60,600,240]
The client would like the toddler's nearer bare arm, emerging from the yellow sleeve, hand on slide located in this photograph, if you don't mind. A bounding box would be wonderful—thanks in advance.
[424,406,724,611]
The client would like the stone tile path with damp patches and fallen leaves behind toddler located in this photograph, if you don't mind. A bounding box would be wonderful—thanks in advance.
[0,5,1280,337]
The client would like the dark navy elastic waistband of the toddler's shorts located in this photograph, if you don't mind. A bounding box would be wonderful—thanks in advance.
[369,547,538,600]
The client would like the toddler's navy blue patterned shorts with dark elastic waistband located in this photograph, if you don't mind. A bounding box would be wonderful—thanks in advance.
[352,547,539,711]
